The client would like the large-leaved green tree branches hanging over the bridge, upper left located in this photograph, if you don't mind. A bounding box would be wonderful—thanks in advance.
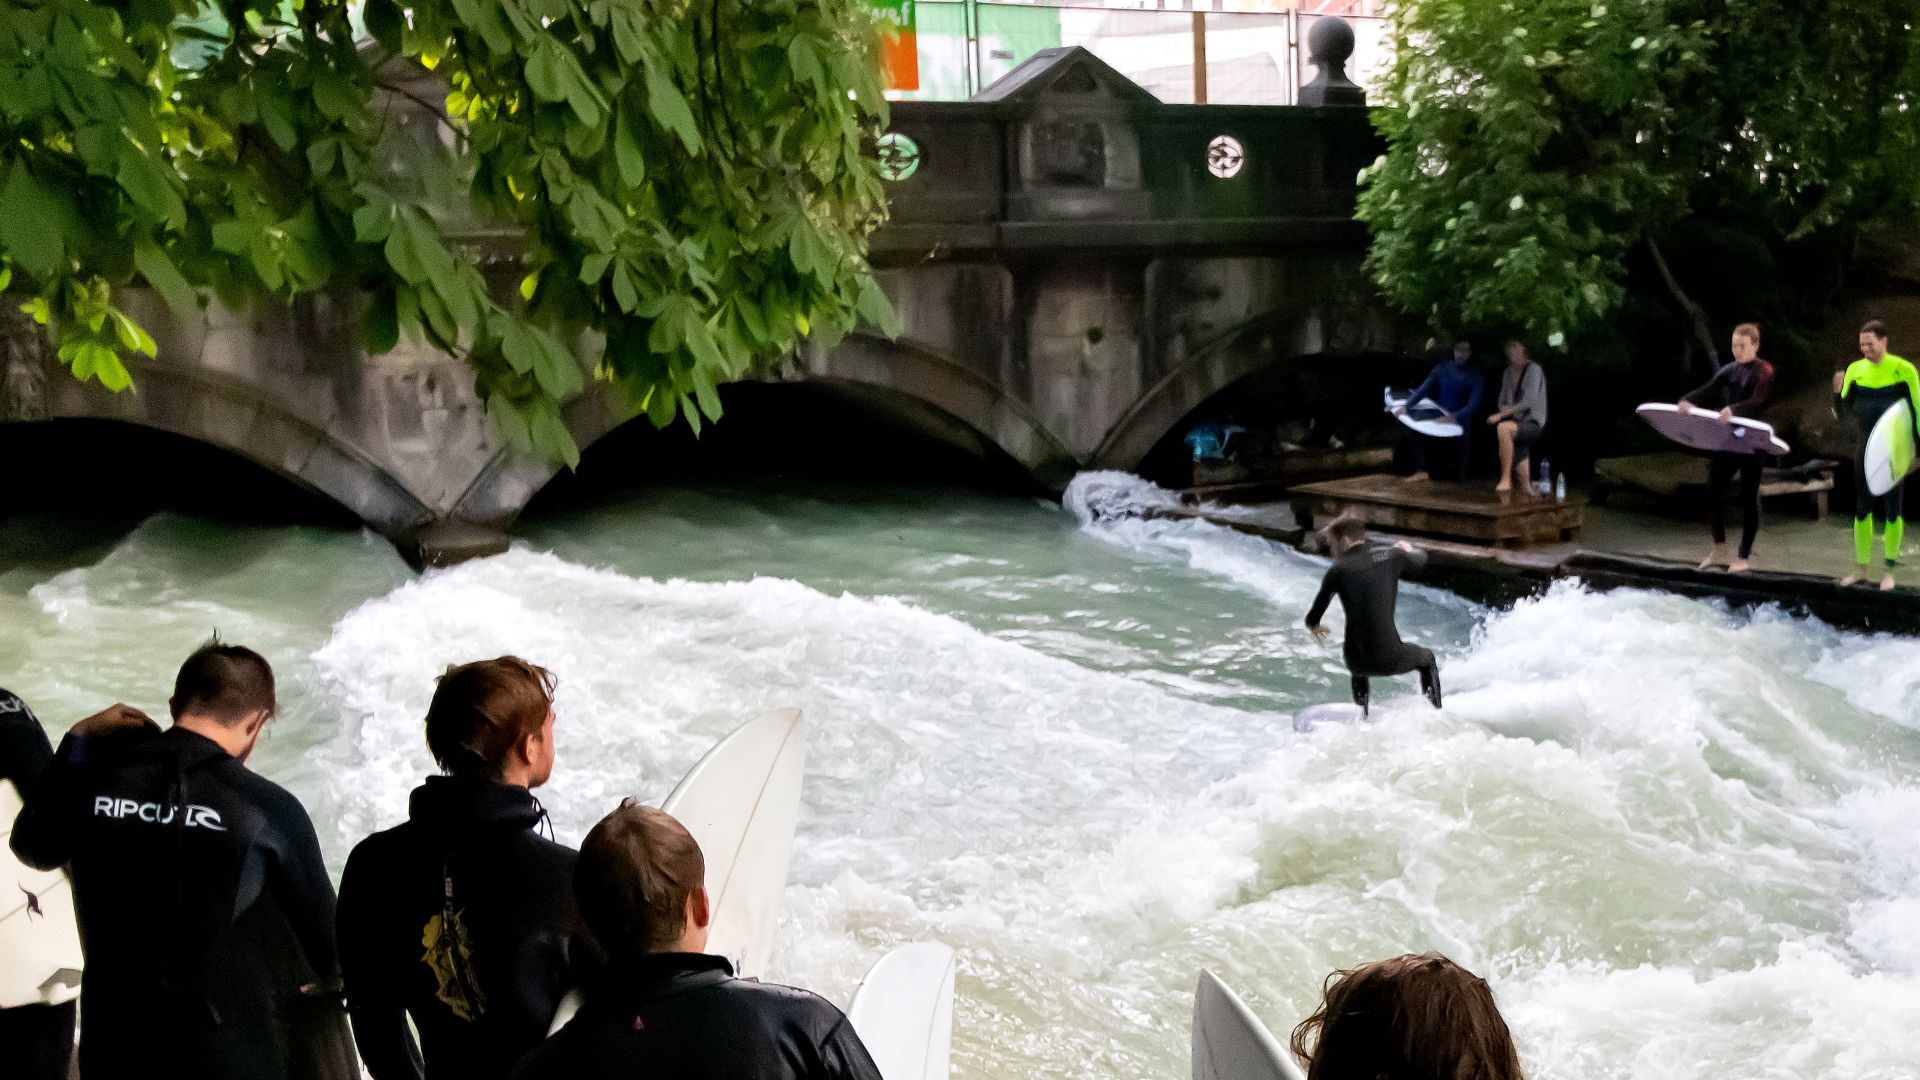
[0,0,893,463]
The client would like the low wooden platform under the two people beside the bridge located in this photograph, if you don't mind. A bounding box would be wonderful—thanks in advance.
[1292,473,1586,548]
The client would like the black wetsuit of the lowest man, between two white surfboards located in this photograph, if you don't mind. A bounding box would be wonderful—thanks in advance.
[513,953,879,1080]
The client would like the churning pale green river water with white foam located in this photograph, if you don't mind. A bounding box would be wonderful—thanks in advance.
[0,477,1920,1080]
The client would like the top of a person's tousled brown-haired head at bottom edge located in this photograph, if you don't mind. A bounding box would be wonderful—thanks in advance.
[1292,953,1524,1080]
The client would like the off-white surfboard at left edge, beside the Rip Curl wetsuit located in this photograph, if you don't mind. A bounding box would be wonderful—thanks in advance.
[0,780,83,1009]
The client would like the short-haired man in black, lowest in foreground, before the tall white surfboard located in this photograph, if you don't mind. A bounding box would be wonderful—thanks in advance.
[513,799,879,1080]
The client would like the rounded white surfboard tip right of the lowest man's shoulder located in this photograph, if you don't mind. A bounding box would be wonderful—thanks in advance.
[847,942,954,1080]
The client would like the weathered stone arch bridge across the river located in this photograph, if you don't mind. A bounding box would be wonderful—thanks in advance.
[0,25,1405,561]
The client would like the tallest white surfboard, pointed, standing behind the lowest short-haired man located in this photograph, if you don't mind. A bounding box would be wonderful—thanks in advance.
[549,709,806,1032]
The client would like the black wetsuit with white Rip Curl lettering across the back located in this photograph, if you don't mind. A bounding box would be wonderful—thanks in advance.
[13,726,336,1080]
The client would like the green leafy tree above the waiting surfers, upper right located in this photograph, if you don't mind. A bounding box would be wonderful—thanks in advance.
[1359,0,1920,350]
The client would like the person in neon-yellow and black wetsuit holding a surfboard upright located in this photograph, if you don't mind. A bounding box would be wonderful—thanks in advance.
[1834,319,1920,592]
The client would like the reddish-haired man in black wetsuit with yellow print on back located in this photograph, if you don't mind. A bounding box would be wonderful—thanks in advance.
[340,657,597,1080]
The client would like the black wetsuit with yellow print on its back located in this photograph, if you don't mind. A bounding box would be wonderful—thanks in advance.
[340,776,597,1080]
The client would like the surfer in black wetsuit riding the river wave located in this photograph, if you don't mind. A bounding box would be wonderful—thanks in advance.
[1308,513,1440,715]
